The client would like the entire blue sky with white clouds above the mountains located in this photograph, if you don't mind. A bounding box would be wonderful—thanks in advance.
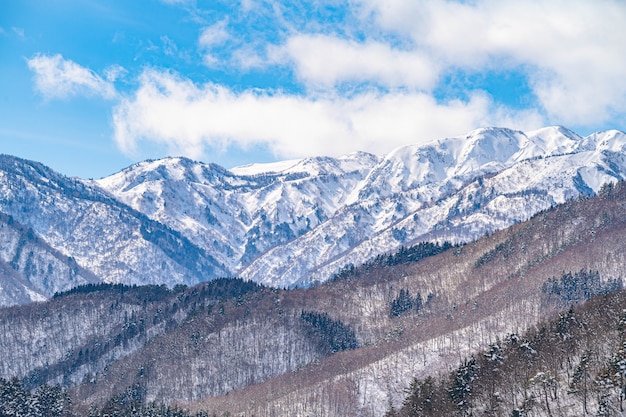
[0,0,626,178]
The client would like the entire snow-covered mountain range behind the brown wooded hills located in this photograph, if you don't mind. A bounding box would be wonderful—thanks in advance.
[0,127,626,305]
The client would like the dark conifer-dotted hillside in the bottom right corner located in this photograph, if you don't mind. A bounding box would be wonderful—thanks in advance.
[385,291,626,417]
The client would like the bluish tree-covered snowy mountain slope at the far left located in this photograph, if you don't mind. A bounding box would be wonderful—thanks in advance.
[0,155,227,302]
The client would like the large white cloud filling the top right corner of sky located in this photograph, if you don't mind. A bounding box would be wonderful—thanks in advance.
[348,0,626,124]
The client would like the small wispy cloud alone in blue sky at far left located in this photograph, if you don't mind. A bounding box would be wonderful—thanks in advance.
[28,54,117,99]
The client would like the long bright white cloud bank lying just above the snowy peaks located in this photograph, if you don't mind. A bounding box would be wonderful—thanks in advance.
[113,70,542,158]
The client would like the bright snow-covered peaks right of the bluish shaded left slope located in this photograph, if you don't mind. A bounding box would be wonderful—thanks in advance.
[94,127,626,287]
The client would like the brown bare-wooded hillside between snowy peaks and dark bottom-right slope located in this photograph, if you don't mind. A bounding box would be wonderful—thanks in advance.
[0,183,626,416]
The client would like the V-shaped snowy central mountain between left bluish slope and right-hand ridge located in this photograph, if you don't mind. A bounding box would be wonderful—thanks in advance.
[96,153,378,274]
